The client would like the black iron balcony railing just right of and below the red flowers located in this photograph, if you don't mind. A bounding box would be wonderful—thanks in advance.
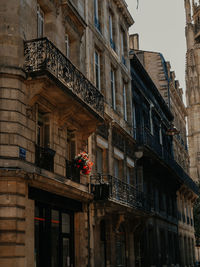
[91,174,152,212]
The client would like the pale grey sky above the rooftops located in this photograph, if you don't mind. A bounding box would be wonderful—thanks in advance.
[126,0,186,91]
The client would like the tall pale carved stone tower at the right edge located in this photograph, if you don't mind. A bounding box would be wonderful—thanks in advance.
[185,0,200,182]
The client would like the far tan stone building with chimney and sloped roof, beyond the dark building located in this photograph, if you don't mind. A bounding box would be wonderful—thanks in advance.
[130,35,198,265]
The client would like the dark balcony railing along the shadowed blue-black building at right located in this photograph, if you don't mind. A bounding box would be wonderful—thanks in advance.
[136,128,199,194]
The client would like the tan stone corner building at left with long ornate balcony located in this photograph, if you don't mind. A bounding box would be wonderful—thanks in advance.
[0,0,104,267]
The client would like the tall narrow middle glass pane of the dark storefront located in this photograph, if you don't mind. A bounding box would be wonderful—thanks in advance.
[51,210,59,267]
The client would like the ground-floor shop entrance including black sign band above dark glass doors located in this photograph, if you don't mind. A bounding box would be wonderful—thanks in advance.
[29,188,81,267]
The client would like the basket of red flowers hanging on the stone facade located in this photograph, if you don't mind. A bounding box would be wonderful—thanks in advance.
[74,152,93,175]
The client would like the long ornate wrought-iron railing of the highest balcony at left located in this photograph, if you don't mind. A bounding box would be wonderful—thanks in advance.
[24,38,104,116]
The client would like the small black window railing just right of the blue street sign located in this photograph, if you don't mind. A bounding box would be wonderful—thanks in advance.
[35,145,55,172]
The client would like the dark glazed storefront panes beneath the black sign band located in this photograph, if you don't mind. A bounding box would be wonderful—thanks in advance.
[35,203,74,267]
